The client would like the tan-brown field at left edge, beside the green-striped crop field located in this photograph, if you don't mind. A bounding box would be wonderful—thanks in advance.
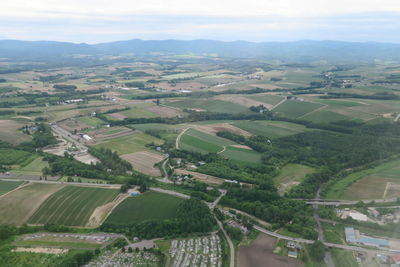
[0,183,64,225]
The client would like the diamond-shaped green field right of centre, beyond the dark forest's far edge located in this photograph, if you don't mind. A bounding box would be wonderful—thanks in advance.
[274,100,323,118]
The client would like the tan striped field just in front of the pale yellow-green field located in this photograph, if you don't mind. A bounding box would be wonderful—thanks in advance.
[121,151,164,176]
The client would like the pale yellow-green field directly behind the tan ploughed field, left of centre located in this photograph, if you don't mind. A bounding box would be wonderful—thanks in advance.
[94,133,162,155]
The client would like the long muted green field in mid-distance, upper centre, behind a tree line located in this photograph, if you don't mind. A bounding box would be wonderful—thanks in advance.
[166,99,249,113]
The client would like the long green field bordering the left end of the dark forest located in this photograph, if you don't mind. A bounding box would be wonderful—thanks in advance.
[233,121,308,138]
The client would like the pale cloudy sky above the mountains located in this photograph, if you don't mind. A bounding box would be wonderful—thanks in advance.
[0,0,400,43]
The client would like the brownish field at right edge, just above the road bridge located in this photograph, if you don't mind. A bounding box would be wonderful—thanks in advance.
[343,176,400,200]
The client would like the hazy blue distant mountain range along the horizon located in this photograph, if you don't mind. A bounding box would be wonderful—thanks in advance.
[0,39,400,62]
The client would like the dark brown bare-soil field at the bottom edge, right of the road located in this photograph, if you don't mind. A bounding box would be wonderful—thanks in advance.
[237,234,304,267]
